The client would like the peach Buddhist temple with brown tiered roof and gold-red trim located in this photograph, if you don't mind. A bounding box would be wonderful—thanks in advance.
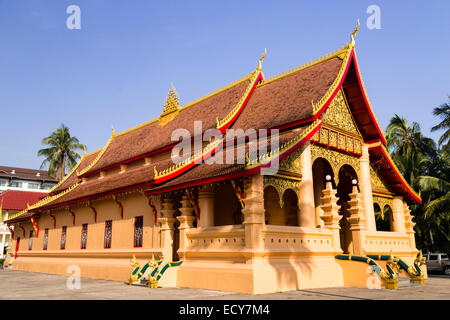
[6,30,421,293]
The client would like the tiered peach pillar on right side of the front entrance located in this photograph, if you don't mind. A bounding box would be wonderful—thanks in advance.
[348,180,367,256]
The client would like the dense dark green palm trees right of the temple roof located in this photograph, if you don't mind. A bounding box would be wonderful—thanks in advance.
[386,115,450,251]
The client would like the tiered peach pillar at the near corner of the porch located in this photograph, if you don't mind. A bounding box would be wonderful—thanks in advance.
[242,174,265,251]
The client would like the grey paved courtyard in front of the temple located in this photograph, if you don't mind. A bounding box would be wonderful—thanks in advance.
[0,269,450,300]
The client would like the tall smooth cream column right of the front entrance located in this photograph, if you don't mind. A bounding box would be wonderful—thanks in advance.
[359,144,377,231]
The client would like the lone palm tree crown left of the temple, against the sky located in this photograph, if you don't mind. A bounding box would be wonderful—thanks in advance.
[38,124,86,180]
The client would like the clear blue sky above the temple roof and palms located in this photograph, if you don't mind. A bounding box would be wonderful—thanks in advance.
[0,0,450,168]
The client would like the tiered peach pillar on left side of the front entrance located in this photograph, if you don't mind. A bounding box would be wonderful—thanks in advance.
[320,179,342,252]
